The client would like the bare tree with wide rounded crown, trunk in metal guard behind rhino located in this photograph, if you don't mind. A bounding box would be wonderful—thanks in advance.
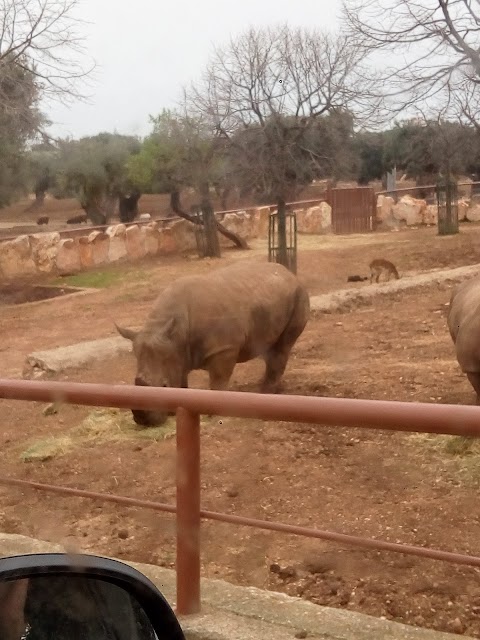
[187,26,374,265]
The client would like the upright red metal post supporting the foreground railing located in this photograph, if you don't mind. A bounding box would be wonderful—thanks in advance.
[176,408,200,615]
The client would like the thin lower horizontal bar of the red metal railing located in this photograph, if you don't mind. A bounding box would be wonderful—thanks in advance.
[0,477,480,567]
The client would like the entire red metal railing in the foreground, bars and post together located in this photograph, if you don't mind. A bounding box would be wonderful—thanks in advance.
[0,379,480,614]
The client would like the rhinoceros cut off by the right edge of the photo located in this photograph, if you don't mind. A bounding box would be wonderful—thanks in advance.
[447,276,480,404]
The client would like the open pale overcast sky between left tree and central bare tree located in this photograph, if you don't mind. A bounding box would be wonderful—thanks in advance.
[48,0,340,138]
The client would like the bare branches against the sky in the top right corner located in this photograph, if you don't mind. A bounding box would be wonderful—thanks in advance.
[343,0,480,126]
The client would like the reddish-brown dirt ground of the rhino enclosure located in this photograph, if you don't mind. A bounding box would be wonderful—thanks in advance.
[0,224,480,637]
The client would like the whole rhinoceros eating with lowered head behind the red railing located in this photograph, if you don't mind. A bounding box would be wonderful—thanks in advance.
[116,260,310,426]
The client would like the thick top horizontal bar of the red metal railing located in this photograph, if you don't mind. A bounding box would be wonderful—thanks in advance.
[0,379,480,436]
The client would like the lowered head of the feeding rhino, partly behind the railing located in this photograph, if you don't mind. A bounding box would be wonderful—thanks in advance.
[115,318,186,427]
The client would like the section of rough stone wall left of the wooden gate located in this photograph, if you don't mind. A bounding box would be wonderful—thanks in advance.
[0,202,332,279]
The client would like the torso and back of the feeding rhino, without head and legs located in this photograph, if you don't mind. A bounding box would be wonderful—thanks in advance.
[147,261,309,366]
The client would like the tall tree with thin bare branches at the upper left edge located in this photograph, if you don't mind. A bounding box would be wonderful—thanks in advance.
[0,0,94,206]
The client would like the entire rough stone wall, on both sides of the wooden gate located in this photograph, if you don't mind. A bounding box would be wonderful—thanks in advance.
[9,195,480,280]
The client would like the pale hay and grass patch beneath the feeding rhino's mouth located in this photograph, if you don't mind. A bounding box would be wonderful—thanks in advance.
[20,409,182,462]
